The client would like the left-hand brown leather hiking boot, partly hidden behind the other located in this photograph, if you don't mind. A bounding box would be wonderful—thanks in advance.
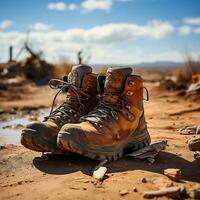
[21,65,97,153]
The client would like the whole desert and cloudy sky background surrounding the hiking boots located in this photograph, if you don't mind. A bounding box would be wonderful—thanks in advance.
[0,0,200,200]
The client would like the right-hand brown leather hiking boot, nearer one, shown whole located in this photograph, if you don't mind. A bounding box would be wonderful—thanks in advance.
[57,68,150,161]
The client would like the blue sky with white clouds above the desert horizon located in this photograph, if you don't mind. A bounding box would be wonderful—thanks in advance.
[0,0,200,64]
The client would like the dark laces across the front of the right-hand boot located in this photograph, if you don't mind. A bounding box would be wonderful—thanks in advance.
[81,93,130,127]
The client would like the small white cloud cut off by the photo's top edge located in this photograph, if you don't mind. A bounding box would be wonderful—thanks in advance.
[81,0,113,11]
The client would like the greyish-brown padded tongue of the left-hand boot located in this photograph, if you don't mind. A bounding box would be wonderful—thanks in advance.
[68,65,92,88]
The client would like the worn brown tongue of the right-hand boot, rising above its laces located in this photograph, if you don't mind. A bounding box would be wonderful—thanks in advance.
[104,67,132,93]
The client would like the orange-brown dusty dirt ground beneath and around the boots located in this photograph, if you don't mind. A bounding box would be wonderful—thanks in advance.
[0,83,200,200]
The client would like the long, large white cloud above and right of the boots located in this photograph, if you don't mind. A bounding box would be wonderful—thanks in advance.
[85,20,174,43]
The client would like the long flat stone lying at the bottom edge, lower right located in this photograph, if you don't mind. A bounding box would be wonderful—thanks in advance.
[143,187,181,199]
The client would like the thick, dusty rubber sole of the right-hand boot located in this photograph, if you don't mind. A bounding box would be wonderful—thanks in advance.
[57,128,151,161]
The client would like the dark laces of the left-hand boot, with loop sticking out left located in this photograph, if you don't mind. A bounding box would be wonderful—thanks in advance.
[44,79,90,125]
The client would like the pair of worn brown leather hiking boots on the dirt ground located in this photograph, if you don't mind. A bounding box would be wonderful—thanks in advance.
[21,65,150,161]
